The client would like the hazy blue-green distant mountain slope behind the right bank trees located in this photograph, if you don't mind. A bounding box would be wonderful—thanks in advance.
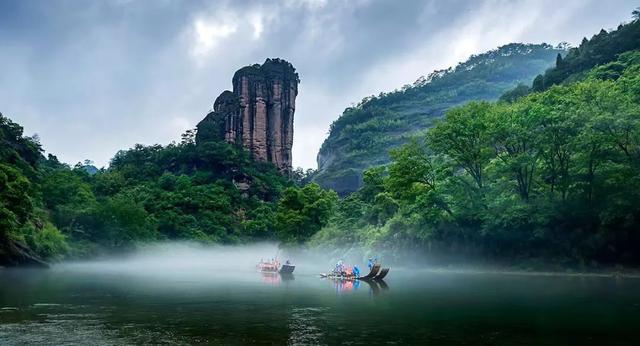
[314,43,565,195]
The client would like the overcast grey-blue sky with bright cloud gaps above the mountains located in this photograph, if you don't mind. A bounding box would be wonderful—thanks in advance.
[0,0,640,168]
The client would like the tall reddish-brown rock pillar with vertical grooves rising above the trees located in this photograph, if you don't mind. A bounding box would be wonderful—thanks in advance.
[196,59,299,171]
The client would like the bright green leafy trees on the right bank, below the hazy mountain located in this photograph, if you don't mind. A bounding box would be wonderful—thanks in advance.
[313,51,640,264]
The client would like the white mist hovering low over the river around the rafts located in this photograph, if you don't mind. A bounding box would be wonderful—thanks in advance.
[52,242,639,284]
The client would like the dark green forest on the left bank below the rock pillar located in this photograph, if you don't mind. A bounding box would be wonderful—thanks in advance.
[0,117,337,259]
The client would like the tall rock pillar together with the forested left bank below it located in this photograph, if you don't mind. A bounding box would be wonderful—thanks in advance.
[0,59,337,265]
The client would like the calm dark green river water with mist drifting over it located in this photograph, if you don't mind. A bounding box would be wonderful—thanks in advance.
[0,245,640,345]
